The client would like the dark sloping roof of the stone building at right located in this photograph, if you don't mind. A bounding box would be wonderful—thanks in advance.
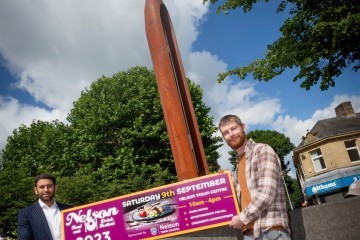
[296,113,360,148]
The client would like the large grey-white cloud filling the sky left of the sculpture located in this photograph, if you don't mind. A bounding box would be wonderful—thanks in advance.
[0,1,151,111]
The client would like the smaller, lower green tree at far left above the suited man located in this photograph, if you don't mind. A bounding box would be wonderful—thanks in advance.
[2,120,75,176]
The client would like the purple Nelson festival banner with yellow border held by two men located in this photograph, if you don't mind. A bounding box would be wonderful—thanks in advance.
[62,172,239,240]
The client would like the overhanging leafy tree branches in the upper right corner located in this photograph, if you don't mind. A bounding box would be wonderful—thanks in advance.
[203,0,360,90]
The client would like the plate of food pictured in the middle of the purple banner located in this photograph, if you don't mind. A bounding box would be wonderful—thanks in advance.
[132,202,175,221]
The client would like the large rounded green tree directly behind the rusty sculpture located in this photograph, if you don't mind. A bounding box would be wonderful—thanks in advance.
[67,67,220,193]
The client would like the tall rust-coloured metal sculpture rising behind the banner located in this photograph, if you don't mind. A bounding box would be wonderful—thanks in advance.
[145,0,209,181]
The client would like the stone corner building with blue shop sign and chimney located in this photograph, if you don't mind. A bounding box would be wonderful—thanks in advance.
[293,102,360,204]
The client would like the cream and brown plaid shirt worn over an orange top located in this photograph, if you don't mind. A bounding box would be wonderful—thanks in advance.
[235,139,290,239]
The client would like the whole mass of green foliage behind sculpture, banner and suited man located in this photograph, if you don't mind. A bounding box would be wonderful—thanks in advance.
[0,67,221,238]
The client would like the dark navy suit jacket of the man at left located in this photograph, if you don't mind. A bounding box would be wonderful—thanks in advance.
[18,202,71,240]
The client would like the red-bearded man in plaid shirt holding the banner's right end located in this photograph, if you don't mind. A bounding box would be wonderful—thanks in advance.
[219,115,291,240]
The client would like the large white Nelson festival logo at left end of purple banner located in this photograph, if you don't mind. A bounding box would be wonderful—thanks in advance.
[65,207,119,232]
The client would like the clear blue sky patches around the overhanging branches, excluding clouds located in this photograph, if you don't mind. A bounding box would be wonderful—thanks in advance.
[194,2,360,118]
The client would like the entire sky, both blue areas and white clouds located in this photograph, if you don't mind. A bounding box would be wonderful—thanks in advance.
[0,0,360,176]
